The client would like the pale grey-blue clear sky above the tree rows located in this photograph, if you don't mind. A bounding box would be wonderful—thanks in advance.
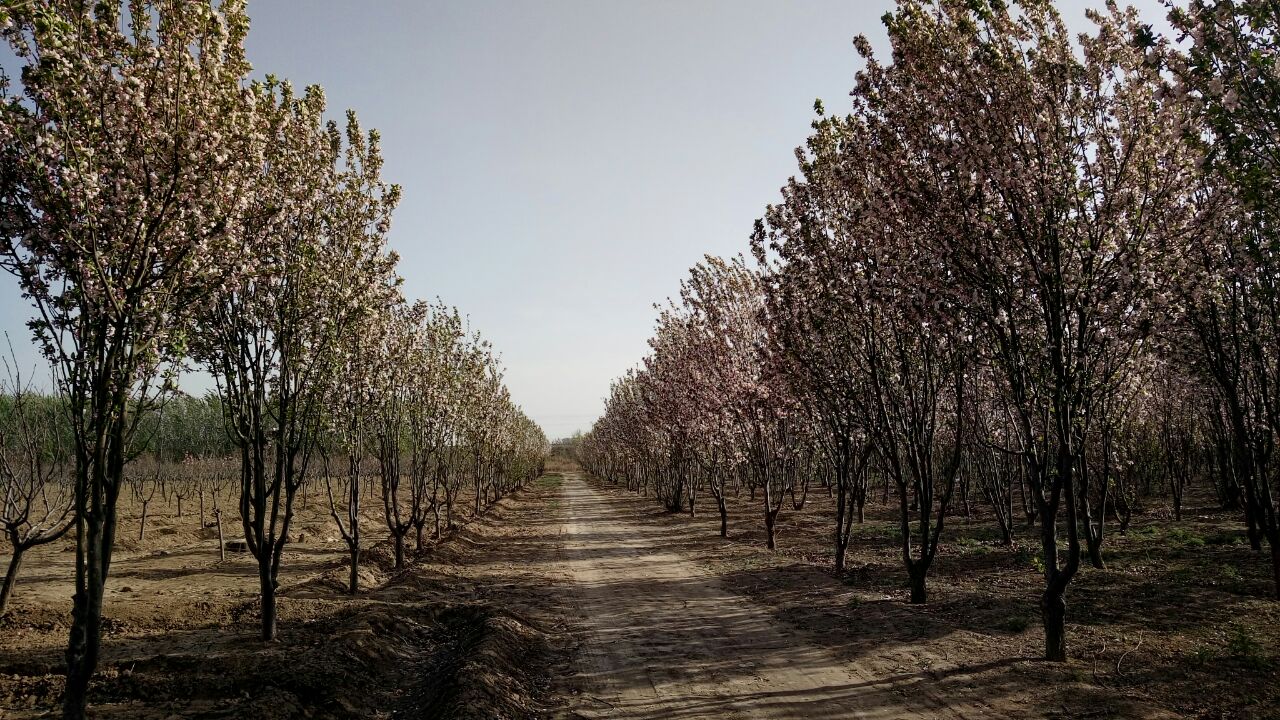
[0,0,1165,438]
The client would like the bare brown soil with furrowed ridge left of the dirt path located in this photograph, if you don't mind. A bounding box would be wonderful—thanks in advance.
[0,479,570,719]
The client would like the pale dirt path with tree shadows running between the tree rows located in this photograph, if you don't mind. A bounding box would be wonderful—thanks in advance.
[556,474,975,720]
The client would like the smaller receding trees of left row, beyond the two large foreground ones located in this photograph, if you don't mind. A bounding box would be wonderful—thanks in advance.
[316,302,549,594]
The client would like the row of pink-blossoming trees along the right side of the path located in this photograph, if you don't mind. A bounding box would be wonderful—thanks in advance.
[581,0,1280,660]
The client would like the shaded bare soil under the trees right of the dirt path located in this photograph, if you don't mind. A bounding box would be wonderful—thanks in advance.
[590,471,1280,719]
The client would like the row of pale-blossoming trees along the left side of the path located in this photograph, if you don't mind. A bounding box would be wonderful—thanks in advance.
[0,0,545,717]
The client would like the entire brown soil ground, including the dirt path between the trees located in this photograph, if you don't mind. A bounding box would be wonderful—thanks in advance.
[0,458,1280,720]
